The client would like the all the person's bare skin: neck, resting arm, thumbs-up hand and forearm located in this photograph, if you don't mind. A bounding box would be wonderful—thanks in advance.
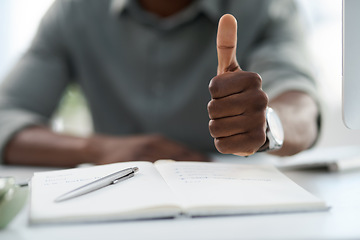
[4,0,318,167]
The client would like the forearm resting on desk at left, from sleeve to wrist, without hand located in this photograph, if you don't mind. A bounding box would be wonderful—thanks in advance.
[4,127,92,167]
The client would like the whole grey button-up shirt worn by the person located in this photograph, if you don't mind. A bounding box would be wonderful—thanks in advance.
[0,0,316,161]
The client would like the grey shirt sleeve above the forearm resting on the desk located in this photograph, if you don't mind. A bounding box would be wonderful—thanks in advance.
[0,1,71,162]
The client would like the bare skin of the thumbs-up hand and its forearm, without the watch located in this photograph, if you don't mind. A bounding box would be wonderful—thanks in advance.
[208,14,318,156]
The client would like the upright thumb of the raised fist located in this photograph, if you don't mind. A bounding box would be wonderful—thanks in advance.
[216,14,241,75]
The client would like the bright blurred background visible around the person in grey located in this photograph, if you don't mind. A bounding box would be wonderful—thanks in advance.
[0,0,360,147]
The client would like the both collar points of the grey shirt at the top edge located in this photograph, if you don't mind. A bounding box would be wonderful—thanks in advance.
[110,0,222,23]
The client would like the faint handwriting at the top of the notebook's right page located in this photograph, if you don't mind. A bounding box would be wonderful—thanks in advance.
[174,165,271,183]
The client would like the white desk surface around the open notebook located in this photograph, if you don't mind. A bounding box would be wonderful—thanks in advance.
[0,154,360,240]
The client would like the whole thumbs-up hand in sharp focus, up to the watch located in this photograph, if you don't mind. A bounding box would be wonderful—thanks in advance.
[208,14,268,156]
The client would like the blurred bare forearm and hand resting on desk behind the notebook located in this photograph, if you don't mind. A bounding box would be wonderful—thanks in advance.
[4,127,208,167]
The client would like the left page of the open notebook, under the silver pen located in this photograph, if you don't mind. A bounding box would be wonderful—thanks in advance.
[30,162,179,223]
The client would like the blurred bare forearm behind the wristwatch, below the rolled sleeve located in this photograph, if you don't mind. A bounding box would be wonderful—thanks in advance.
[269,91,319,156]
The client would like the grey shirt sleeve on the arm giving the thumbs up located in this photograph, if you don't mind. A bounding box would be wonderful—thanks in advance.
[245,0,323,142]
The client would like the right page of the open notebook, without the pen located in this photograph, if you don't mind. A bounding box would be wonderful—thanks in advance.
[156,161,326,215]
